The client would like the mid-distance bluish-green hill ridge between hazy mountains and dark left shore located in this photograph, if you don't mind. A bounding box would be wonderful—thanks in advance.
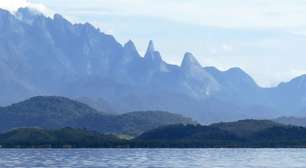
[0,96,194,135]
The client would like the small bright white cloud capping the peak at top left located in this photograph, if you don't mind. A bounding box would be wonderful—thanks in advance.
[0,0,52,15]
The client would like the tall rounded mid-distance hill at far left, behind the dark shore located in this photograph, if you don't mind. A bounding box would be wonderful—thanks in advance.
[0,96,99,132]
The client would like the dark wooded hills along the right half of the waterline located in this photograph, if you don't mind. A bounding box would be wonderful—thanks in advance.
[134,120,306,148]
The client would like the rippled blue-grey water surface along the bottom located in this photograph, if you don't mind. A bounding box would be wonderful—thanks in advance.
[0,149,306,168]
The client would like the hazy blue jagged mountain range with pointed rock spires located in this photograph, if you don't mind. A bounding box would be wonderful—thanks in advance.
[0,8,306,123]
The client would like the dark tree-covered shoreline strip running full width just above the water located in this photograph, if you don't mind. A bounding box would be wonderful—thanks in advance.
[0,120,306,148]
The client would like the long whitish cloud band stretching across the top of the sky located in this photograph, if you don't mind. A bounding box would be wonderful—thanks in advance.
[41,0,306,28]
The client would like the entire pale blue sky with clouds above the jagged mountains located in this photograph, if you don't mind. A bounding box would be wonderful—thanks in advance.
[0,0,306,87]
